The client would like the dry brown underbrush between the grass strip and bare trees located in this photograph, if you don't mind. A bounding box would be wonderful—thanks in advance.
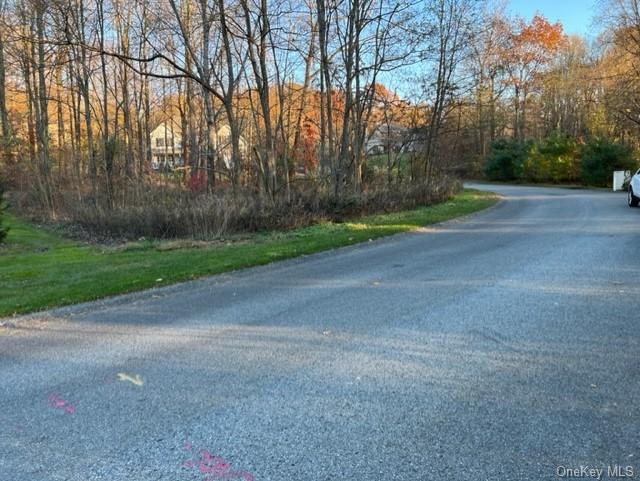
[14,177,462,241]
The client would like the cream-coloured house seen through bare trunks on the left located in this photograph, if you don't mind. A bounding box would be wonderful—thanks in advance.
[151,122,249,170]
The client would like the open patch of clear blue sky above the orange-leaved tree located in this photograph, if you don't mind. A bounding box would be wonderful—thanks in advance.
[507,0,598,36]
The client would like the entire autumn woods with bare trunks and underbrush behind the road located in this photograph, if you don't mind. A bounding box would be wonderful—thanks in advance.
[0,0,640,238]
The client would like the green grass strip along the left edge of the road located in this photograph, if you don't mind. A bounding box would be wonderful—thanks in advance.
[0,190,497,317]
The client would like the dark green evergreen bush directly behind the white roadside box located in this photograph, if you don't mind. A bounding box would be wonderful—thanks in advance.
[582,139,636,187]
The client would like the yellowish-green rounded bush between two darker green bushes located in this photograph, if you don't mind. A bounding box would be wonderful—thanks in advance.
[522,135,580,183]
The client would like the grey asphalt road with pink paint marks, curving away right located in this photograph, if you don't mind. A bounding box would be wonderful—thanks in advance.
[0,186,640,481]
